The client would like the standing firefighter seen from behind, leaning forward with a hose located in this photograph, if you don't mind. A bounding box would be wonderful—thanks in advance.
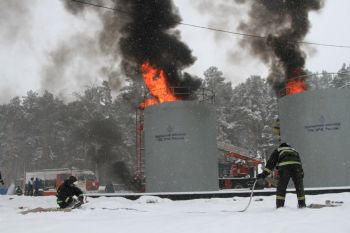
[257,143,306,208]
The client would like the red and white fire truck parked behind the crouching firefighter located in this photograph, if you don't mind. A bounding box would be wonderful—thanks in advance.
[25,168,99,195]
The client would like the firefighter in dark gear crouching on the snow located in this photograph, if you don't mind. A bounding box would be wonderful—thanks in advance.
[57,176,84,208]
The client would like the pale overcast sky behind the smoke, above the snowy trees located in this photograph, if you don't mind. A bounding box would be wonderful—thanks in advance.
[0,0,350,103]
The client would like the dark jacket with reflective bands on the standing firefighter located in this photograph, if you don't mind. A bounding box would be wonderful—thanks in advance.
[263,143,301,177]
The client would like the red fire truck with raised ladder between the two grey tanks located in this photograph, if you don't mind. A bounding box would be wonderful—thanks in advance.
[218,143,264,189]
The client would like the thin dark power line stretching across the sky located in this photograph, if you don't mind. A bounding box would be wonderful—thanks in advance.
[71,0,350,49]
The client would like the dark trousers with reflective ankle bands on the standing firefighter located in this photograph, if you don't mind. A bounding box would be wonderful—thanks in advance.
[276,164,306,208]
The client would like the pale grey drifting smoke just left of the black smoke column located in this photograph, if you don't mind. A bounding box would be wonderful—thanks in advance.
[41,0,123,98]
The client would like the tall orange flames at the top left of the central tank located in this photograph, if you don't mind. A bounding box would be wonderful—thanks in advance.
[139,61,179,109]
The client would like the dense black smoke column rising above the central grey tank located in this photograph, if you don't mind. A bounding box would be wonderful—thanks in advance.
[118,0,201,98]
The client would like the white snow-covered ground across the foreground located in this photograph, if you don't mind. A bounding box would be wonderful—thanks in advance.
[0,193,350,233]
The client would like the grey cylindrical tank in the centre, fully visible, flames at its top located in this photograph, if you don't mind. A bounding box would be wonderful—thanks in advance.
[144,101,218,192]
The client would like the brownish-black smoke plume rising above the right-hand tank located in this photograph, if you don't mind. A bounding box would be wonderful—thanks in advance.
[239,0,323,93]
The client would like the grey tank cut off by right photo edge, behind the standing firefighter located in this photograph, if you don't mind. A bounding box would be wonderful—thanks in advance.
[279,88,350,187]
